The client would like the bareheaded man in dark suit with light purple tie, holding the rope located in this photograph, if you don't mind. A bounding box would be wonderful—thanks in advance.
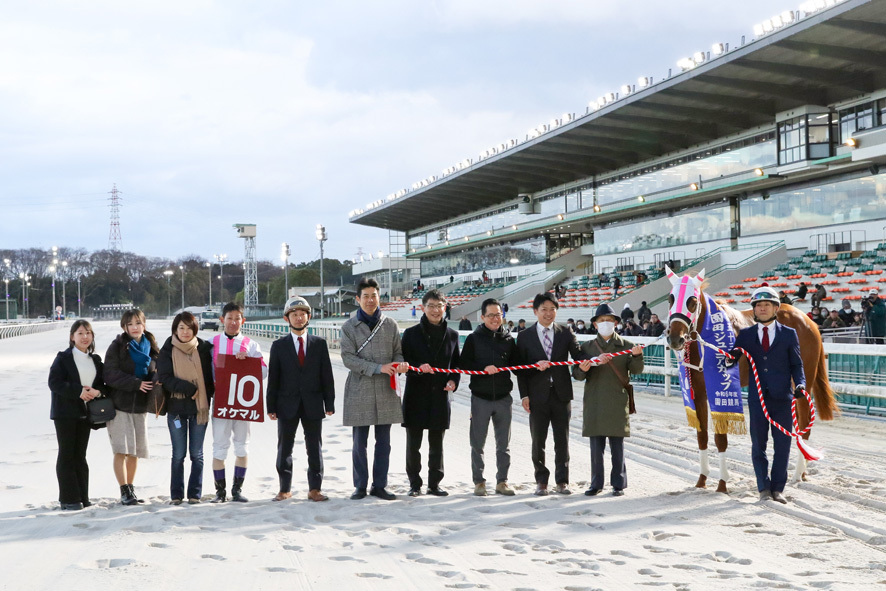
[517,292,584,496]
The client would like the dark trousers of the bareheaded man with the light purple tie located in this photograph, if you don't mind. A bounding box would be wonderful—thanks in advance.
[529,391,572,484]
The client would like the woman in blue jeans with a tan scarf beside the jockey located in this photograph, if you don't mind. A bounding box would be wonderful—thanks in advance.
[157,312,215,505]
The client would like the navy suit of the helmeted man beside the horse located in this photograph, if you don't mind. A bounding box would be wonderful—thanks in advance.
[735,322,806,492]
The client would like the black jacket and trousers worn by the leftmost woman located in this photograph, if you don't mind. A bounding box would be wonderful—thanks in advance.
[49,349,107,504]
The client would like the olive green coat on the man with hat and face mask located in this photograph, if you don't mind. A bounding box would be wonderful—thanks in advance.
[572,334,643,437]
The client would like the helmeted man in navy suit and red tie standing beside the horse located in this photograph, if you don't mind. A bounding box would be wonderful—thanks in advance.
[726,286,806,503]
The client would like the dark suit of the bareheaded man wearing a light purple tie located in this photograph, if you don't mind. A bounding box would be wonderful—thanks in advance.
[517,322,583,485]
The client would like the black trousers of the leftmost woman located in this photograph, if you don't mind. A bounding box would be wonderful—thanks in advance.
[53,419,92,504]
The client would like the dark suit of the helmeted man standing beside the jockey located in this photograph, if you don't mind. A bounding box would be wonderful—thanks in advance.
[267,334,335,492]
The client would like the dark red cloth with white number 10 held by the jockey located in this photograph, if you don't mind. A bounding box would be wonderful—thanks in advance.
[212,355,265,423]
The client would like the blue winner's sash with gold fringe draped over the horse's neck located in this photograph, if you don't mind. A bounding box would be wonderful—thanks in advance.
[680,294,747,434]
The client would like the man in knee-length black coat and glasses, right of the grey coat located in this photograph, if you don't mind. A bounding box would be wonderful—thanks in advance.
[401,289,459,497]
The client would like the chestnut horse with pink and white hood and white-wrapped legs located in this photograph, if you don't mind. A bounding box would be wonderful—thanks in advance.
[665,267,840,493]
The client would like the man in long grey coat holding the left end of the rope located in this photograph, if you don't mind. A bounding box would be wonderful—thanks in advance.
[341,277,408,501]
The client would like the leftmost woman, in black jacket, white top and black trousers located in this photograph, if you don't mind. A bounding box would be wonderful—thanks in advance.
[49,320,106,511]
